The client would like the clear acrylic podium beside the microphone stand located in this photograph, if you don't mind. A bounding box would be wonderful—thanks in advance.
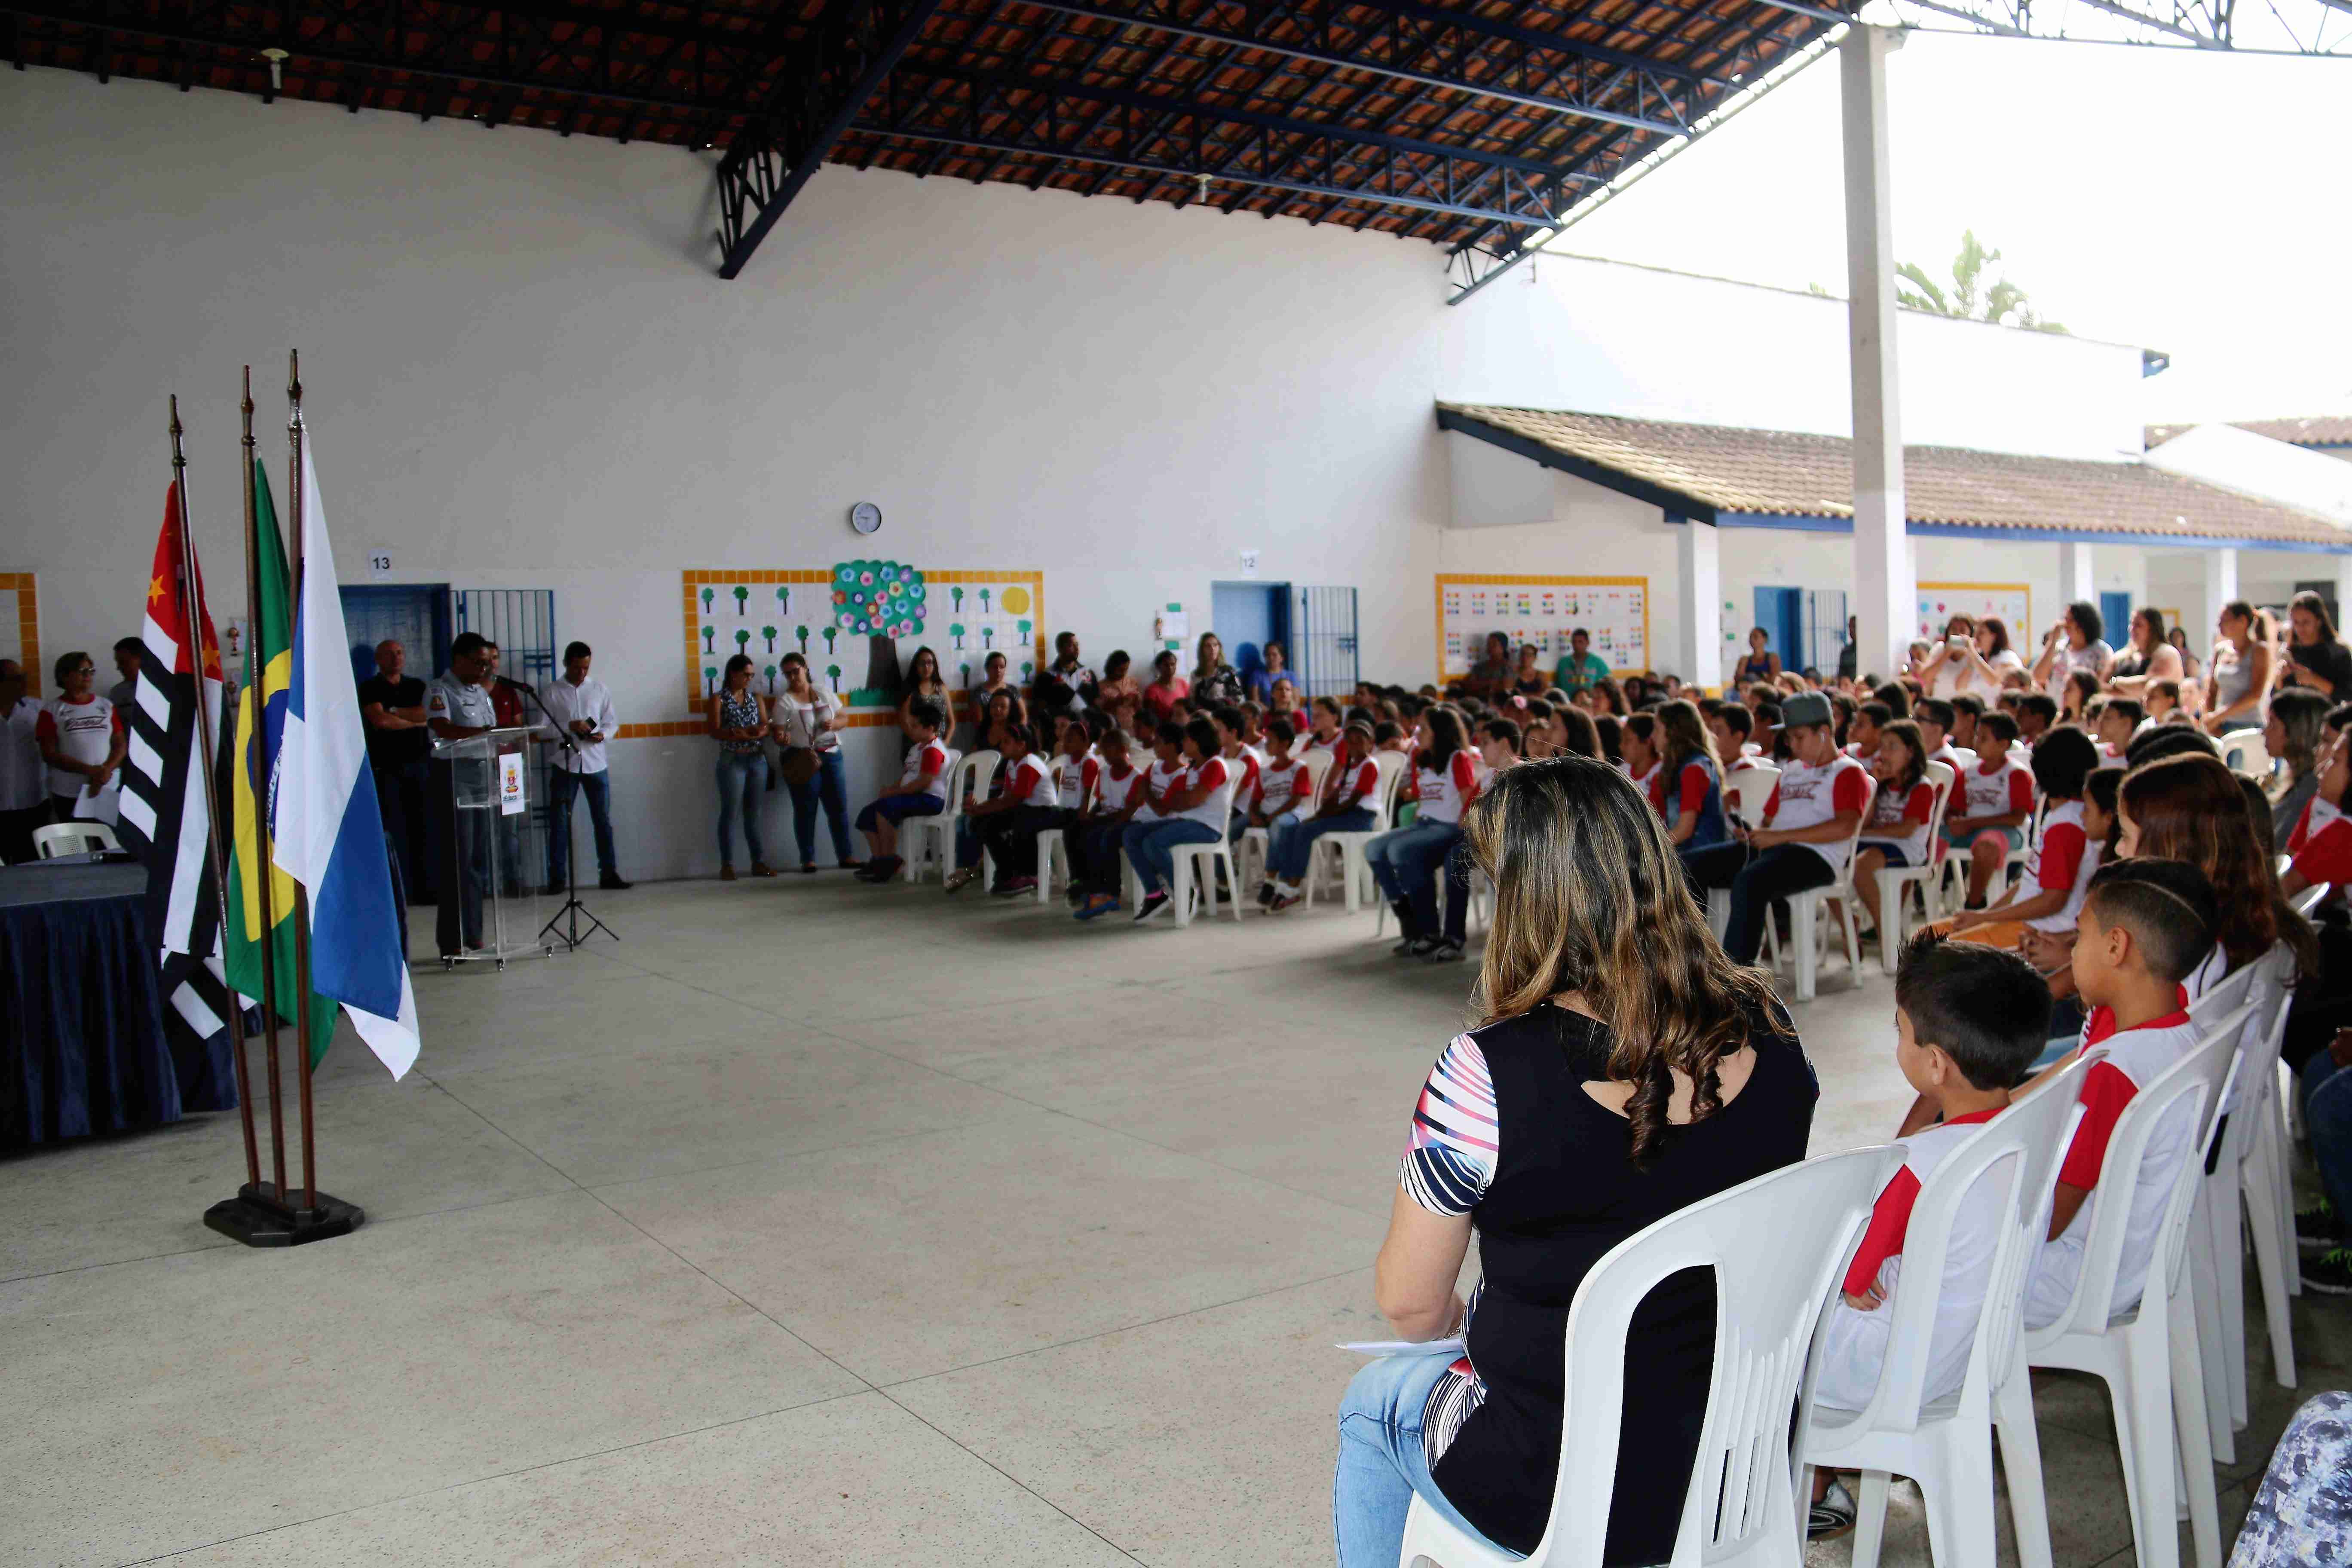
[433,726,553,968]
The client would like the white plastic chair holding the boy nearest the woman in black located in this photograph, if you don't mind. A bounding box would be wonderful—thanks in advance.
[1799,1060,2089,1568]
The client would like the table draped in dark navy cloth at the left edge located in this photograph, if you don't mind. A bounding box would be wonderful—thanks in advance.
[0,863,238,1149]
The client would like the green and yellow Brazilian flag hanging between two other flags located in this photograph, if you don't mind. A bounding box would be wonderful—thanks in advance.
[221,461,341,1067]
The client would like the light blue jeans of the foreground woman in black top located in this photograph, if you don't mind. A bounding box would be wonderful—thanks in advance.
[1331,1352,1514,1568]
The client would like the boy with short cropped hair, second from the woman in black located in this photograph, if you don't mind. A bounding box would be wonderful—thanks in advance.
[2025,858,2216,1328]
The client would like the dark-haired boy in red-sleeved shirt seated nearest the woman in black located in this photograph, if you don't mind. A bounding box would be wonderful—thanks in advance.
[1809,933,2051,1535]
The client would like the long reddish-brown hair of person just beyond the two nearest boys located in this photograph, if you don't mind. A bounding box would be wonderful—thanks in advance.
[2114,752,2319,1001]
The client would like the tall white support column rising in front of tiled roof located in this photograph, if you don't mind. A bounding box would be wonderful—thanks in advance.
[1839,26,1919,670]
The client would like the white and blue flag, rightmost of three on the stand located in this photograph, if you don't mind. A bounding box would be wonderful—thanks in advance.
[270,432,416,1079]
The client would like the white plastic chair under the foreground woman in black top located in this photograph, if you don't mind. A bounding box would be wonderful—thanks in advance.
[1397,1147,1903,1568]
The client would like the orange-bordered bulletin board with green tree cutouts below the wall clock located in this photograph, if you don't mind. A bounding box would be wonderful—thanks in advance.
[680,560,1047,722]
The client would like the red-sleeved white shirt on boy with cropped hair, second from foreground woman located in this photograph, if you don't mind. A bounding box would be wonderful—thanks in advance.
[2025,1001,2199,1328]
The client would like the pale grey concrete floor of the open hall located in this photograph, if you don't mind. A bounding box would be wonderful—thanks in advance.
[0,872,2352,1568]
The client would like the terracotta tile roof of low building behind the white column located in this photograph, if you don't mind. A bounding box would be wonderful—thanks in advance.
[1437,402,2352,548]
